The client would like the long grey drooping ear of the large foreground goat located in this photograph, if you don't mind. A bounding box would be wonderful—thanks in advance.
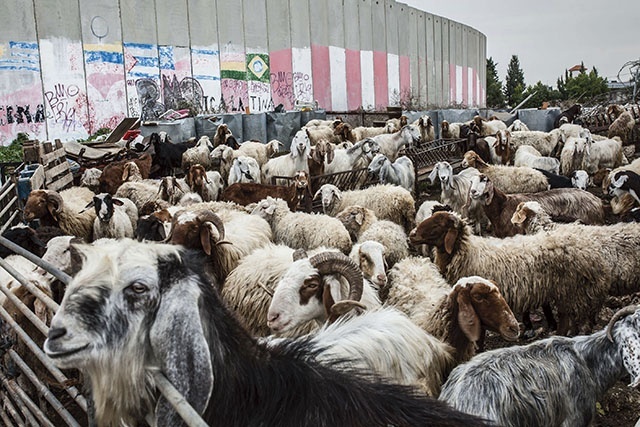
[149,283,213,426]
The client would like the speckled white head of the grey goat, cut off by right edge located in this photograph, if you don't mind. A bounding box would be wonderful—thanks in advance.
[607,305,640,387]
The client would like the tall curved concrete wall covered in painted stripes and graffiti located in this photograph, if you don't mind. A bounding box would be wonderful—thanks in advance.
[0,0,486,145]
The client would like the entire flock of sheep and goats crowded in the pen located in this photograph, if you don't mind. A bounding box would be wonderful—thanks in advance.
[0,106,640,426]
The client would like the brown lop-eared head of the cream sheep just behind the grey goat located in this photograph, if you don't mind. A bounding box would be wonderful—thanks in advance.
[449,276,520,343]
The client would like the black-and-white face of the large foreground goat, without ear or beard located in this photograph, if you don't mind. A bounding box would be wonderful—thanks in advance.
[44,240,169,369]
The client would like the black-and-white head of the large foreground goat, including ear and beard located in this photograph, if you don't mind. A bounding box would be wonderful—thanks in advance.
[44,239,219,425]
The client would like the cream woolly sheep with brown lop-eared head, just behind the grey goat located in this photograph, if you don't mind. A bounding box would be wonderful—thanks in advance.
[384,264,520,364]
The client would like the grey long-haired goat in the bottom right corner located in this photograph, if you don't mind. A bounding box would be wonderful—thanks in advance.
[440,306,640,426]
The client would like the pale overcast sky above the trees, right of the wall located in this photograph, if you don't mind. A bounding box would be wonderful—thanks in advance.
[399,0,640,86]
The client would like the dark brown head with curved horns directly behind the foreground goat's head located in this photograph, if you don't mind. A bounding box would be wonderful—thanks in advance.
[168,210,229,255]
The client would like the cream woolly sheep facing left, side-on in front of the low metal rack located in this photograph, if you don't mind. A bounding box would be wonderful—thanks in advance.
[314,184,416,230]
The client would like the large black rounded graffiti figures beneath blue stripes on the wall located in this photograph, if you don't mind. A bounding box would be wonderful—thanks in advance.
[136,75,205,121]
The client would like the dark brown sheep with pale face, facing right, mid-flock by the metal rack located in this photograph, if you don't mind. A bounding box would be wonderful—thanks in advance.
[220,171,313,211]
